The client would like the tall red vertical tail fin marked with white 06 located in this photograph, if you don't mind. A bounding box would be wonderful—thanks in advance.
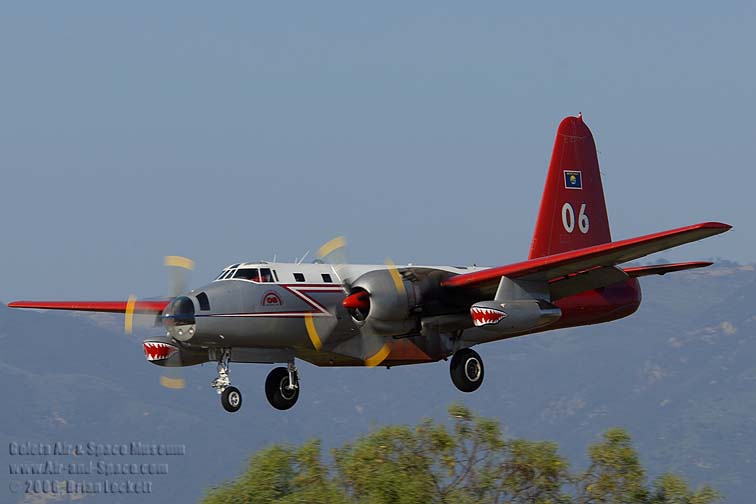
[530,116,612,259]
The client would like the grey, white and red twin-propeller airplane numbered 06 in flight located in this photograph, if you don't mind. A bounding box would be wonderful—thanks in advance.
[8,114,731,413]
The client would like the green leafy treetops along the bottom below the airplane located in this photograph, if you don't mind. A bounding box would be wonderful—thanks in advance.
[204,405,717,504]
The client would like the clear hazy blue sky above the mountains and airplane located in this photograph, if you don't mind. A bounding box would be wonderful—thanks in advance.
[0,1,756,302]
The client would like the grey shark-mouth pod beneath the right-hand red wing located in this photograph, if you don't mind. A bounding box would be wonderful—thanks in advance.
[470,299,562,336]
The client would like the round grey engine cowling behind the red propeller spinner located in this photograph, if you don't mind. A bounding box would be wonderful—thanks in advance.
[350,270,420,336]
